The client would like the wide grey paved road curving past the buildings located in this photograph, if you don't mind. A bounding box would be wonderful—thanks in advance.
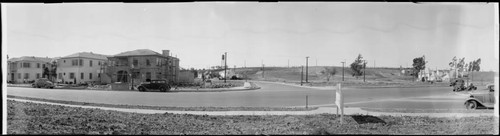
[7,82,470,109]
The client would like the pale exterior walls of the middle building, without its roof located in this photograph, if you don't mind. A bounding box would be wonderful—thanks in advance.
[56,57,106,83]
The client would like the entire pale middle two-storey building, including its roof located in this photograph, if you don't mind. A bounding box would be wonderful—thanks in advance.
[57,52,108,84]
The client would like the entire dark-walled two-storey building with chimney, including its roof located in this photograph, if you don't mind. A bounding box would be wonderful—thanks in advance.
[105,49,179,85]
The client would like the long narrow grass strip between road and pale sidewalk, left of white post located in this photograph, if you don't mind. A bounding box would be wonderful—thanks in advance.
[7,95,318,111]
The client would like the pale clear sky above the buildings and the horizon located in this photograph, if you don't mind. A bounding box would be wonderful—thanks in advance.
[2,2,499,72]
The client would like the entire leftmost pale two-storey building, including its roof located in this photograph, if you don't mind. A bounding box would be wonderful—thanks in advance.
[7,56,54,83]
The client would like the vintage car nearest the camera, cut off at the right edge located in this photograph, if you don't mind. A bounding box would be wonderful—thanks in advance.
[464,85,495,109]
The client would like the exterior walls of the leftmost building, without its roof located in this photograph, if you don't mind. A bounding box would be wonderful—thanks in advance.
[7,61,51,83]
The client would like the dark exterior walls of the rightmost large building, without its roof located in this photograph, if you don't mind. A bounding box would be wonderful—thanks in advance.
[106,55,179,85]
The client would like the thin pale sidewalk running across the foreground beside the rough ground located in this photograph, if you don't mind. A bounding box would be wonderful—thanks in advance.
[7,98,494,117]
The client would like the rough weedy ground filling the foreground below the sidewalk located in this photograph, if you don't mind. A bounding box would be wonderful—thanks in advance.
[7,101,498,135]
